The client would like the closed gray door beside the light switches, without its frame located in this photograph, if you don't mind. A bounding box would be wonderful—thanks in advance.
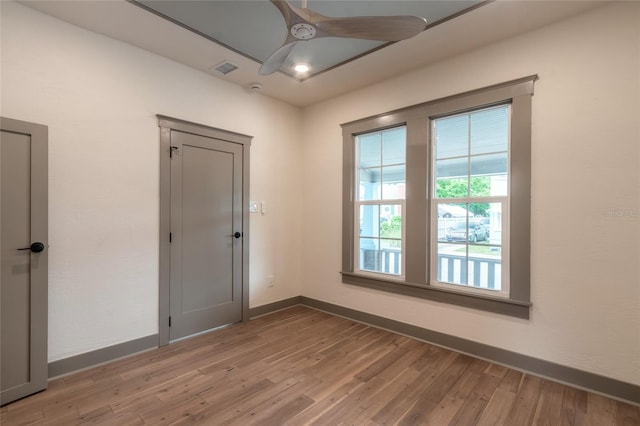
[169,130,243,340]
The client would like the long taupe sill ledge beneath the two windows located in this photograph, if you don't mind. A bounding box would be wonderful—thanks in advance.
[341,271,531,319]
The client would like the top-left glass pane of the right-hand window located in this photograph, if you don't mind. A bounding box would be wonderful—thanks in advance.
[434,114,469,159]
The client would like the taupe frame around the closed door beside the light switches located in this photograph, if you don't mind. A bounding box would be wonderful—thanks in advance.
[156,115,253,346]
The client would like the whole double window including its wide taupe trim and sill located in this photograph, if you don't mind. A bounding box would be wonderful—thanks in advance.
[342,76,537,318]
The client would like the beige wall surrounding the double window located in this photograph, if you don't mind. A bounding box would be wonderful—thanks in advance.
[302,2,640,384]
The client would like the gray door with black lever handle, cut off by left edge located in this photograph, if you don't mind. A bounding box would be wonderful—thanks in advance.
[0,118,48,404]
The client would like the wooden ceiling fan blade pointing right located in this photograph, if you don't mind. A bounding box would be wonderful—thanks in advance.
[313,16,427,41]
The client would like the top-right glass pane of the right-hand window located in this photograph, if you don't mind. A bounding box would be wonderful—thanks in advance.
[470,105,509,155]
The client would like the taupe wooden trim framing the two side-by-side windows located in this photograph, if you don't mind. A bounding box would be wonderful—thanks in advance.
[341,75,538,319]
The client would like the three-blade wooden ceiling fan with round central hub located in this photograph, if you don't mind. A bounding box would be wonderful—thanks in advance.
[258,0,427,75]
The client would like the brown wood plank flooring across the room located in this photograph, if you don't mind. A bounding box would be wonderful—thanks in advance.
[0,306,640,426]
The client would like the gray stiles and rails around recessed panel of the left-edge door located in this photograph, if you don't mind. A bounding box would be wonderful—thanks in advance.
[0,117,49,404]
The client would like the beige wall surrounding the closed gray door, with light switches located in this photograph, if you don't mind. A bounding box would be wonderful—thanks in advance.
[0,1,301,361]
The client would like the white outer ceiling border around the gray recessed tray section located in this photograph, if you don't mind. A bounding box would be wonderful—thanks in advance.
[21,0,606,106]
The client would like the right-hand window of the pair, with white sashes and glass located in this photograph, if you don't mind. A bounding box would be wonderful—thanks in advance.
[430,104,510,297]
